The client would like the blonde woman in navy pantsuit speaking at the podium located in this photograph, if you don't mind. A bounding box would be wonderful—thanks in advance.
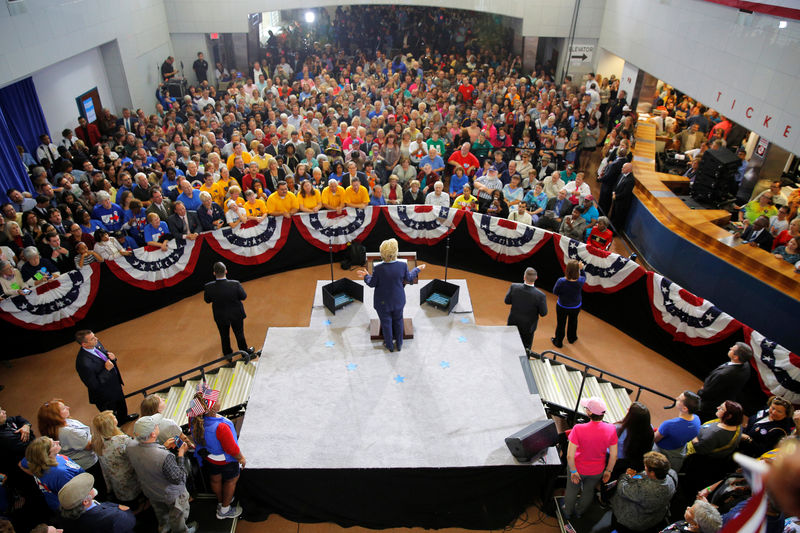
[358,239,425,352]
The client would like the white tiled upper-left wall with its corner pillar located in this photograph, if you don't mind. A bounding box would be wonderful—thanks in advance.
[0,0,171,113]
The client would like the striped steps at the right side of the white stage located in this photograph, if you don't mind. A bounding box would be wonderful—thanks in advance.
[529,357,632,422]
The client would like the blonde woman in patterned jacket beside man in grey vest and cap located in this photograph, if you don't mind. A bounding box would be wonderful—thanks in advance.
[92,411,142,509]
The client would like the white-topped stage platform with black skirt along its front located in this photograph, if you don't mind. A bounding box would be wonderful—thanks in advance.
[239,280,560,529]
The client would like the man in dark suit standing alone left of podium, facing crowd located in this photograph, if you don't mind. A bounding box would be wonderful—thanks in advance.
[204,263,253,355]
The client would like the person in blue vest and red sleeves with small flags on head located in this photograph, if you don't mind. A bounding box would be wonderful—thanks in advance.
[191,392,246,520]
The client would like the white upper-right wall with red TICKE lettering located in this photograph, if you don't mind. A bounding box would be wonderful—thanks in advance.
[600,0,800,154]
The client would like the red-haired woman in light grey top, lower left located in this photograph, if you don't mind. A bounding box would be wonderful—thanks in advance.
[37,398,106,501]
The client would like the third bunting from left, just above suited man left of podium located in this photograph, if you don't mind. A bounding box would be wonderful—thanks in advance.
[206,217,292,265]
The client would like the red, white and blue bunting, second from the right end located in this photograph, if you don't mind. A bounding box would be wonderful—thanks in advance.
[647,272,742,346]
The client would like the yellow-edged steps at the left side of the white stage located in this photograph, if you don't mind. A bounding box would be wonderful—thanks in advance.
[156,360,258,426]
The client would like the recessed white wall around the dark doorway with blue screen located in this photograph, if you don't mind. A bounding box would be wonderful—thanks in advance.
[32,48,116,144]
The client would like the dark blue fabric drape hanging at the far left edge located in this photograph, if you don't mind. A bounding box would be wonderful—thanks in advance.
[0,78,50,201]
